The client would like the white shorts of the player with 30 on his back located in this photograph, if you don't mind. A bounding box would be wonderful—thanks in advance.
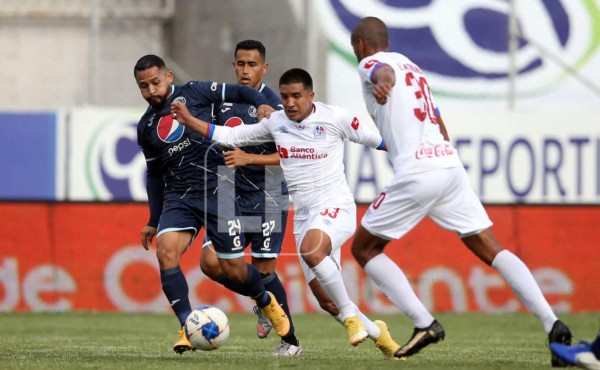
[361,167,492,240]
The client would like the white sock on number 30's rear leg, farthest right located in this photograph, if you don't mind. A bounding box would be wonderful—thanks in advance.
[492,249,558,333]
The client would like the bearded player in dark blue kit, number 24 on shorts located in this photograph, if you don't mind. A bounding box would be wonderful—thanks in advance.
[134,55,290,353]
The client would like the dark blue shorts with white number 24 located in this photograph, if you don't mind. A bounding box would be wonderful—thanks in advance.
[157,194,246,258]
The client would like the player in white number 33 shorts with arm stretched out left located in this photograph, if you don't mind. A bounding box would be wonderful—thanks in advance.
[171,68,400,357]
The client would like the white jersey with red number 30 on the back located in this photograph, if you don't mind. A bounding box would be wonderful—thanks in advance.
[358,52,462,176]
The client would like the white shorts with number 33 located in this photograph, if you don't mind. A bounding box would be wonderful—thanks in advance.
[294,202,356,283]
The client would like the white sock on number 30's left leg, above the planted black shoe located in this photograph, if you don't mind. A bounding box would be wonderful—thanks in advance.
[365,253,434,328]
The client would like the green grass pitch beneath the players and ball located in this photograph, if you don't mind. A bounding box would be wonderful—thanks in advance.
[0,313,600,370]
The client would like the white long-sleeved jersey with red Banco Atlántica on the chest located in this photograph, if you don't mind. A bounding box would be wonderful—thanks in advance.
[209,102,382,216]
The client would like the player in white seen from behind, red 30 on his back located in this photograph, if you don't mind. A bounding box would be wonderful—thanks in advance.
[351,17,571,366]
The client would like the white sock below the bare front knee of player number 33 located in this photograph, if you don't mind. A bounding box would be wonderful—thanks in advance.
[312,256,358,320]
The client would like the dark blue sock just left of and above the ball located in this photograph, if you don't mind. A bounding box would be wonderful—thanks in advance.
[160,266,192,326]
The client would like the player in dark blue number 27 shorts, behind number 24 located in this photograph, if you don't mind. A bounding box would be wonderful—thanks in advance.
[201,40,303,357]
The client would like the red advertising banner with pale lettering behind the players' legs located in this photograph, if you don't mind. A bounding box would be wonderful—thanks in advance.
[0,202,600,313]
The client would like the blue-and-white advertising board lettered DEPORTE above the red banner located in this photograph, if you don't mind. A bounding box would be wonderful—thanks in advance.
[0,107,600,205]
